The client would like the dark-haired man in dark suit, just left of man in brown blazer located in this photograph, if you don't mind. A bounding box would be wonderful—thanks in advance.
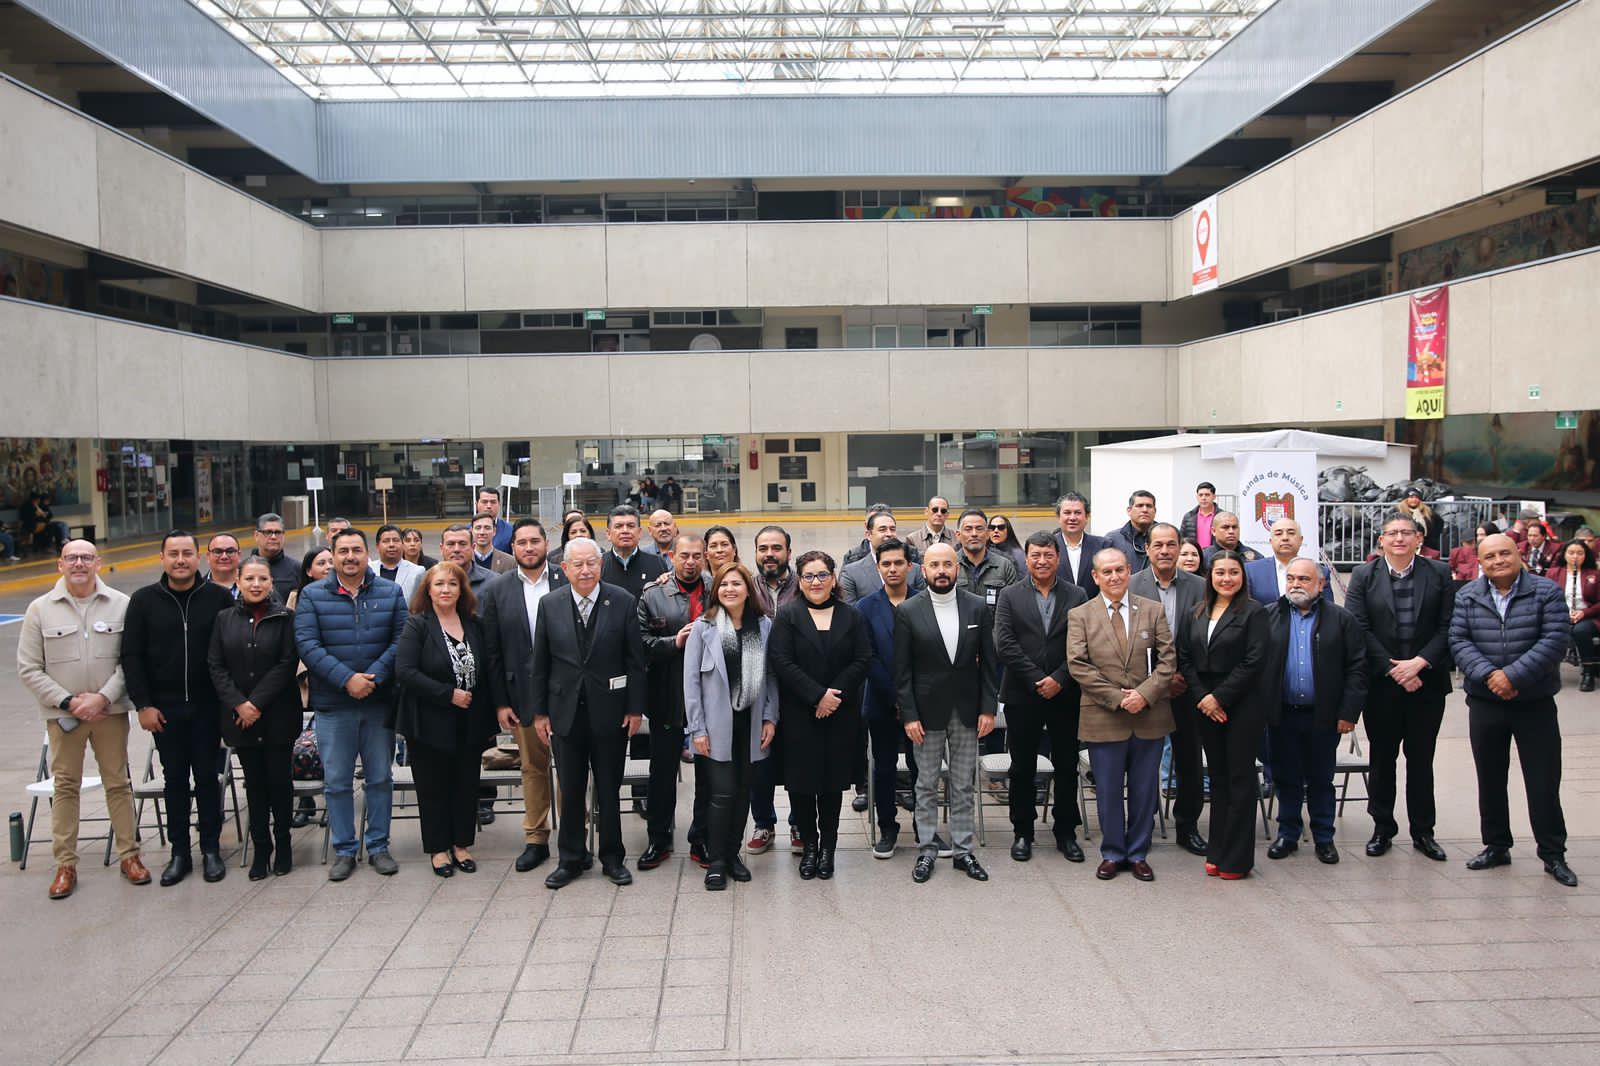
[995,530,1088,863]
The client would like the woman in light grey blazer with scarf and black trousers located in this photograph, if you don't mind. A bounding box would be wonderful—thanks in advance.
[683,562,778,892]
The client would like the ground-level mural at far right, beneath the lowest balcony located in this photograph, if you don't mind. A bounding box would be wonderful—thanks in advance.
[1397,411,1600,491]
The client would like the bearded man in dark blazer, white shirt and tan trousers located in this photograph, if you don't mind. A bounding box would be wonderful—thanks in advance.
[478,519,566,874]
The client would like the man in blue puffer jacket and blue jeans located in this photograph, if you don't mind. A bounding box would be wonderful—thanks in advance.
[294,530,406,880]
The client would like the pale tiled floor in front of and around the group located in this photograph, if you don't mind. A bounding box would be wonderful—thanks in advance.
[0,525,1600,1066]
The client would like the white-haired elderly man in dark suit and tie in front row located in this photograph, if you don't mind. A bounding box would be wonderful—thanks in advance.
[517,536,645,888]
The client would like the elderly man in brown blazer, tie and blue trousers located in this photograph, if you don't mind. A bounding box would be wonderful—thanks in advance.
[1067,547,1178,880]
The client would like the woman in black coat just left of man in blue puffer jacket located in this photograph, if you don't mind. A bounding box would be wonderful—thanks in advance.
[206,555,301,880]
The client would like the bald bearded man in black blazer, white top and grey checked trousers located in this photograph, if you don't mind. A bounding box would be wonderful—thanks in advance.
[894,544,995,884]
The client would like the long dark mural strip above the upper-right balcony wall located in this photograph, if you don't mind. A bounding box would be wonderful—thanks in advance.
[1400,197,1600,291]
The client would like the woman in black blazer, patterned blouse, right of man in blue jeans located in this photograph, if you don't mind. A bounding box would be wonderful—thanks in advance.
[395,562,496,877]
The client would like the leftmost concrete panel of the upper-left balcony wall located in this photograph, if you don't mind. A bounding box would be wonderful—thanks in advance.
[0,80,99,248]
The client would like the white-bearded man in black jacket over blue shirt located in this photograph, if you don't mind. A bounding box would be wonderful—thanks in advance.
[1267,559,1366,863]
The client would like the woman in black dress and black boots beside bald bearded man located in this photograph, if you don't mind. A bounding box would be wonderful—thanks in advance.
[766,551,872,880]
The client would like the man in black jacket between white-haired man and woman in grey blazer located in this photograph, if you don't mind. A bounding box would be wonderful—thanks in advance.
[638,533,712,869]
